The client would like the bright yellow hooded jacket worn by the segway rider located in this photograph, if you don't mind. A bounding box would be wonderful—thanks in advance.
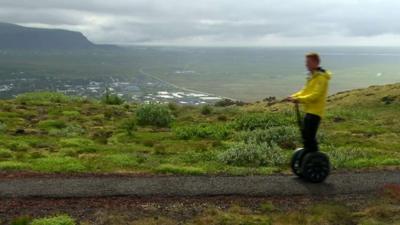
[291,68,331,117]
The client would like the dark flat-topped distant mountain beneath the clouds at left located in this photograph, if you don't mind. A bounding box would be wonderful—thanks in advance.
[0,23,115,50]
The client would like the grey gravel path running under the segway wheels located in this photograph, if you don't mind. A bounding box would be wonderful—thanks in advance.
[0,171,400,198]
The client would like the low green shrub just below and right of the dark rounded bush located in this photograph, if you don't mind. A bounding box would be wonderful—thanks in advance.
[174,124,231,140]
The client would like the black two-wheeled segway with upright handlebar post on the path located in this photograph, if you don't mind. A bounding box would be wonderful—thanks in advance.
[290,103,330,183]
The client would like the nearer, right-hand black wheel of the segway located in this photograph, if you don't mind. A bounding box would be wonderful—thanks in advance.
[301,152,330,183]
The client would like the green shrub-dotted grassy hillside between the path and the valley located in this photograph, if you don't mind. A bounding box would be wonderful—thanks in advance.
[0,84,400,175]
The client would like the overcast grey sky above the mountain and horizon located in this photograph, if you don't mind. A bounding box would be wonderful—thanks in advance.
[0,0,400,46]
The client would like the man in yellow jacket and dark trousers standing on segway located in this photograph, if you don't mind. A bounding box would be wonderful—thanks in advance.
[286,53,331,155]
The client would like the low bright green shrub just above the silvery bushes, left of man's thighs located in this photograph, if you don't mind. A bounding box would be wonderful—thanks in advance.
[233,113,291,130]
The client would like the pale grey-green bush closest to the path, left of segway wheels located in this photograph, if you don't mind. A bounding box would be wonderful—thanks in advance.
[218,141,286,167]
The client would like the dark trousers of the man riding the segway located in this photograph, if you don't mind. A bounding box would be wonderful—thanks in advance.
[301,113,321,152]
